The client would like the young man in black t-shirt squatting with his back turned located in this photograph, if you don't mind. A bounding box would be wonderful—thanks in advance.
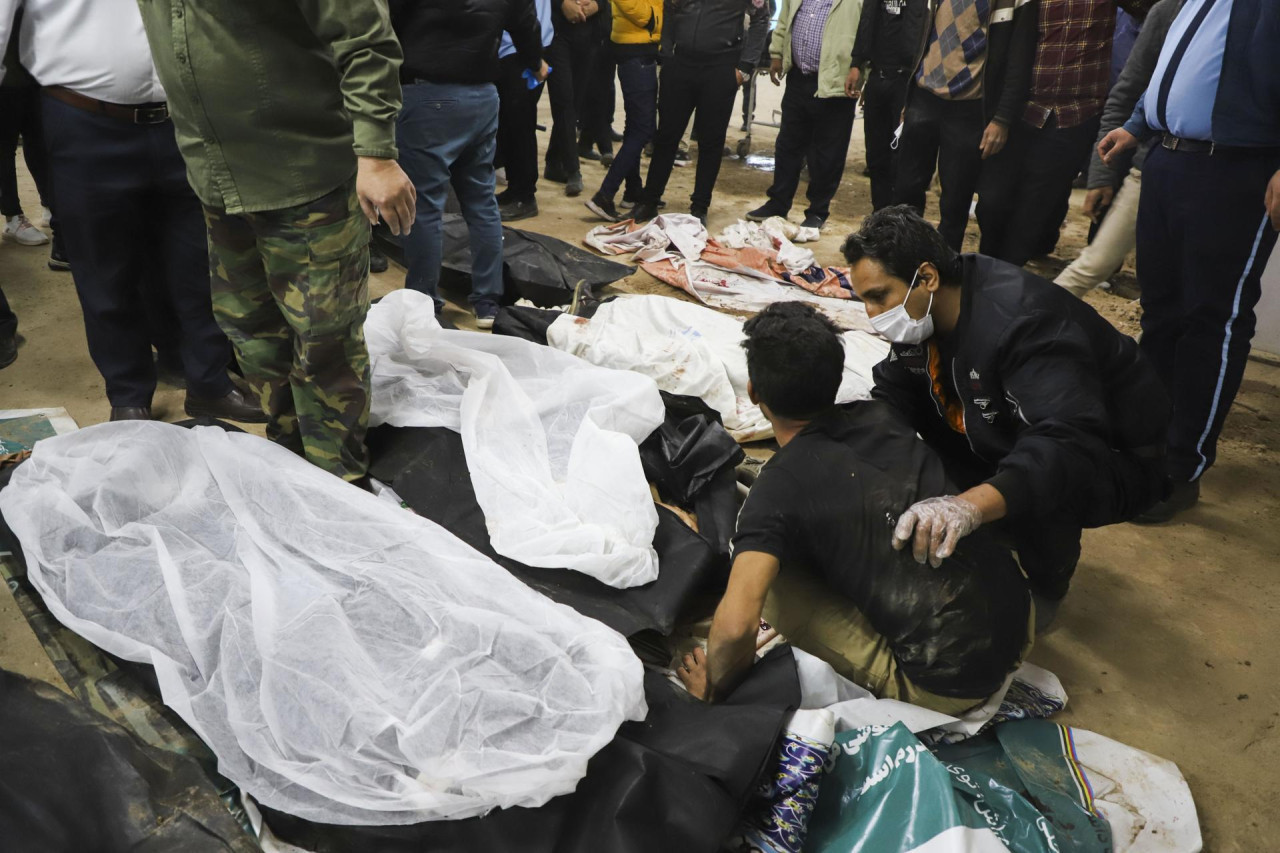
[678,302,1032,713]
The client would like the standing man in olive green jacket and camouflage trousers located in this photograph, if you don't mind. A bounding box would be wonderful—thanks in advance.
[131,0,417,480]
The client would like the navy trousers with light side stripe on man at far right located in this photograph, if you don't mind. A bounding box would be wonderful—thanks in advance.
[1138,143,1280,482]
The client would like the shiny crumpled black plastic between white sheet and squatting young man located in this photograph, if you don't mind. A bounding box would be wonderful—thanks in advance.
[640,391,746,556]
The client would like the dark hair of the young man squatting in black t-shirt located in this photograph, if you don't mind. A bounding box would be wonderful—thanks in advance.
[742,302,845,420]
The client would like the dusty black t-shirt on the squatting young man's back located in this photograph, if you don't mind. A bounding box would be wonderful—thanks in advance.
[733,401,1030,697]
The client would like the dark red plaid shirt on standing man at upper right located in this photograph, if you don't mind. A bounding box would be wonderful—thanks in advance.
[1023,0,1153,128]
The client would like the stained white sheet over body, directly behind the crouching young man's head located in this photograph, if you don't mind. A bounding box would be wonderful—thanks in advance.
[547,296,888,442]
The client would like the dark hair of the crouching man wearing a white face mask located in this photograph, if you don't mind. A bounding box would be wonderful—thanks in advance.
[841,205,960,284]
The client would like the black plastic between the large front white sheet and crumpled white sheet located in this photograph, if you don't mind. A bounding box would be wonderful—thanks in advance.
[369,427,723,637]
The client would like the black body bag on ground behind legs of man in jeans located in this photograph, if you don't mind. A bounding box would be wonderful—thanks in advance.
[376,214,635,307]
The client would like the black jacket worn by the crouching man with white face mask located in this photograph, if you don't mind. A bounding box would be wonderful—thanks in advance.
[872,249,1170,526]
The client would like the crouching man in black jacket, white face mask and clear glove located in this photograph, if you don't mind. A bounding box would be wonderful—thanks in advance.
[844,205,1170,617]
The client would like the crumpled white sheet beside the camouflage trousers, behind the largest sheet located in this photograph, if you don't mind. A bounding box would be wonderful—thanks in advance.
[365,289,664,588]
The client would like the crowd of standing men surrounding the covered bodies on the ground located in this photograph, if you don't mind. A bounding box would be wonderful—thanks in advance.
[0,0,1280,535]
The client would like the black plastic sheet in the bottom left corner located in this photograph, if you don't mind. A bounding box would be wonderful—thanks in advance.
[0,670,260,853]
